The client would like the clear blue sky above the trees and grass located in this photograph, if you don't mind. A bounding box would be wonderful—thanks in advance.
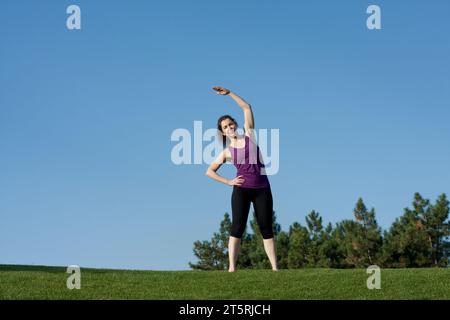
[0,0,450,270]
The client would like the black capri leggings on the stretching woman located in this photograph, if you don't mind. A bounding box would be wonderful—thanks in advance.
[230,186,273,239]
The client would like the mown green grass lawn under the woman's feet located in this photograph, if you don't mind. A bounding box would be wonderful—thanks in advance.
[0,265,450,300]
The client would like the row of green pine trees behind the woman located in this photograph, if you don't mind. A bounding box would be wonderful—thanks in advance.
[189,193,450,270]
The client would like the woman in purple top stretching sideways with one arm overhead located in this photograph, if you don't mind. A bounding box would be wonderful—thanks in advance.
[206,87,278,272]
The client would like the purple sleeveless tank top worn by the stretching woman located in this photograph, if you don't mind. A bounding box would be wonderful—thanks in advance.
[229,135,270,188]
